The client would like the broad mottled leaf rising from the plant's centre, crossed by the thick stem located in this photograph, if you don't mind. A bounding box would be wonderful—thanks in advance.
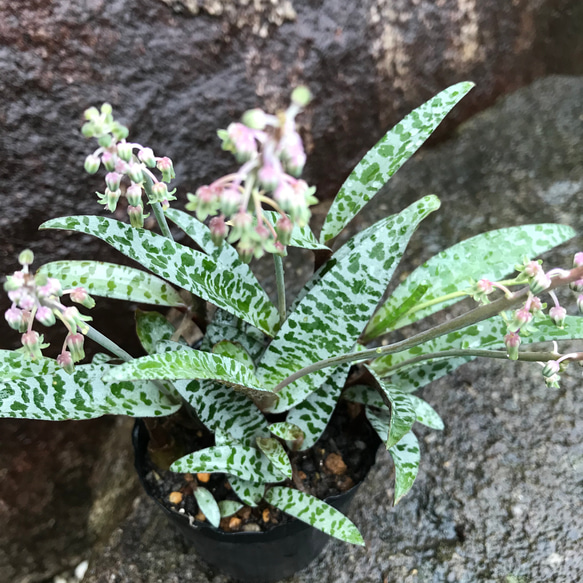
[257,196,439,412]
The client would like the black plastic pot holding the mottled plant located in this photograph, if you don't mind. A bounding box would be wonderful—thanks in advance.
[132,420,378,583]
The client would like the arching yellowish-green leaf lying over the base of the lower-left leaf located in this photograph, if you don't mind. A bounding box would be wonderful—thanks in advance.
[101,349,270,393]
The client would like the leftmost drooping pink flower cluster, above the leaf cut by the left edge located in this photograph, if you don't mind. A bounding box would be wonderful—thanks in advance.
[4,249,95,372]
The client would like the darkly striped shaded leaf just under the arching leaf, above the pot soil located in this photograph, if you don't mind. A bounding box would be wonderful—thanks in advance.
[174,380,270,446]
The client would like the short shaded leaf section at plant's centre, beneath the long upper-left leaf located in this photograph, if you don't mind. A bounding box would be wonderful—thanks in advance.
[200,309,265,362]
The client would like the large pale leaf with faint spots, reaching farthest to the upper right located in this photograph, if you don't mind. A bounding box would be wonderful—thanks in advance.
[363,224,575,342]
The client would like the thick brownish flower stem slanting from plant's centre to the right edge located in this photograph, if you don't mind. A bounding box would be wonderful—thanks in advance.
[273,267,583,393]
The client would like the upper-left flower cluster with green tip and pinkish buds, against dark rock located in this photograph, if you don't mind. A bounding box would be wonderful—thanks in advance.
[81,103,176,228]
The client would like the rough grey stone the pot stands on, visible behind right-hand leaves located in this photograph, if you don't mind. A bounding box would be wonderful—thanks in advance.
[75,77,583,583]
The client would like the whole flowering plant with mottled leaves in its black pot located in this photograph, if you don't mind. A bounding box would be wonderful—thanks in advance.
[0,83,583,581]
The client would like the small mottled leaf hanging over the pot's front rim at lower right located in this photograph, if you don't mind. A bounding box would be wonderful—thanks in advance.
[265,487,364,546]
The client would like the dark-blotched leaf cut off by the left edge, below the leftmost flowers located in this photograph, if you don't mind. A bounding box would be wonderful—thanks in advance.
[0,364,180,421]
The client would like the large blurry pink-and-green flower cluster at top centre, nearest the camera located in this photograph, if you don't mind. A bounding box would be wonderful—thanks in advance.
[186,87,317,261]
